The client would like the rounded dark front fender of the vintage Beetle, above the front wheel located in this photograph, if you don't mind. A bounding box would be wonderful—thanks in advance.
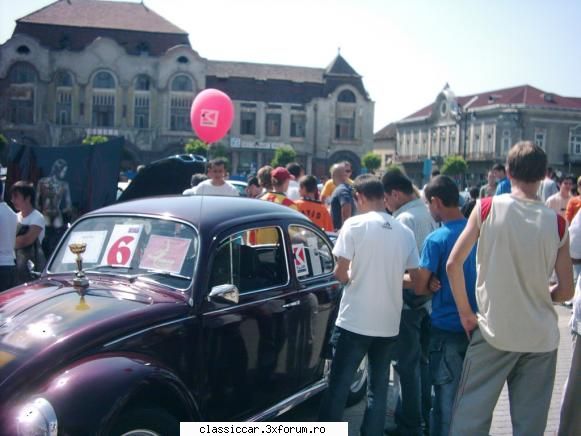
[27,354,200,435]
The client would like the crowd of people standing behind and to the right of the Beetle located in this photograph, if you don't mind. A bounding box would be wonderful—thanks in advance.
[185,145,581,436]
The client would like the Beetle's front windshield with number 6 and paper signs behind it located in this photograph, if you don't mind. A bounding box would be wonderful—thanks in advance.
[48,216,198,289]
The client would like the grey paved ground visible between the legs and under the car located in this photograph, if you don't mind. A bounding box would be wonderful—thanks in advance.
[277,306,571,436]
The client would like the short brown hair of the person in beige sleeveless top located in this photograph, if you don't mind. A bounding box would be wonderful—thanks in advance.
[506,141,547,183]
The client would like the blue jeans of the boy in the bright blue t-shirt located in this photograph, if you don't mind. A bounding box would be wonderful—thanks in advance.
[430,326,469,436]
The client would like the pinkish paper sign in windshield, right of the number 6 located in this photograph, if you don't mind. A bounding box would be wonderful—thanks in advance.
[139,235,190,274]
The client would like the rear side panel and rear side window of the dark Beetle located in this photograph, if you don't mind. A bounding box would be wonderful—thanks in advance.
[288,224,341,387]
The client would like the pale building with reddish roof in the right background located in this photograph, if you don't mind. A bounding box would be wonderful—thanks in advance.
[386,85,581,186]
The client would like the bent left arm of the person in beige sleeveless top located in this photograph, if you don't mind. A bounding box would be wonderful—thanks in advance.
[446,207,480,337]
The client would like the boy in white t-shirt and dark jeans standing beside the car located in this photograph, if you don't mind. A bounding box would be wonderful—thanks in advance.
[319,174,419,436]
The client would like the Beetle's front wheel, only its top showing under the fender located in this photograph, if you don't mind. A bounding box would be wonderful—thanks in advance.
[112,408,180,436]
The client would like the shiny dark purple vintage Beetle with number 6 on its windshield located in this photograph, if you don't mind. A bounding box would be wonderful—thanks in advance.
[0,197,365,436]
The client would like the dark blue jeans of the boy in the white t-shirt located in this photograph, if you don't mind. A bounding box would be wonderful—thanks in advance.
[319,327,397,436]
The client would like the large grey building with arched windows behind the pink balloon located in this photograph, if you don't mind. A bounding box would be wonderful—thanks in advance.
[0,0,374,174]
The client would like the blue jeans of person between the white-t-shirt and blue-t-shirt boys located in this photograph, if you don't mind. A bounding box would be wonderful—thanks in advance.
[395,308,430,436]
